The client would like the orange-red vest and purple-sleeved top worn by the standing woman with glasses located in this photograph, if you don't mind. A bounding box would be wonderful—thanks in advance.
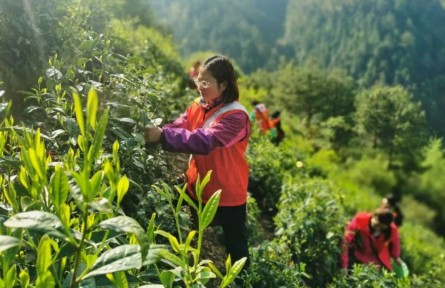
[161,102,250,206]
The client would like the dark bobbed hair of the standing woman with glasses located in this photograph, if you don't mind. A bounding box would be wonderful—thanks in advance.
[202,55,239,103]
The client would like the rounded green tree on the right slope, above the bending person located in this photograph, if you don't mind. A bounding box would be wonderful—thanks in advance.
[356,86,426,170]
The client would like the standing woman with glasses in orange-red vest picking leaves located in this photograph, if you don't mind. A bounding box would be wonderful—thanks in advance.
[144,55,250,268]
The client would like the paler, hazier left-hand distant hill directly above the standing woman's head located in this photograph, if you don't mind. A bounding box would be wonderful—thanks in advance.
[149,0,288,73]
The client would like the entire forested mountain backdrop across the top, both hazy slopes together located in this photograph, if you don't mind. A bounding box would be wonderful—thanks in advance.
[150,0,445,136]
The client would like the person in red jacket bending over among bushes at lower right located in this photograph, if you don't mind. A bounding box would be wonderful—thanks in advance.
[341,208,400,271]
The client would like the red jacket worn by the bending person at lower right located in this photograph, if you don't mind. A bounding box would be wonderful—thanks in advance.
[341,212,400,271]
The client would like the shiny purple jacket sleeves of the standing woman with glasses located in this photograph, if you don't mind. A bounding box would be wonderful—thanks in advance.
[161,111,250,155]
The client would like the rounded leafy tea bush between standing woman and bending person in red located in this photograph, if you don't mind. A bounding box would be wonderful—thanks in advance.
[274,178,346,287]
